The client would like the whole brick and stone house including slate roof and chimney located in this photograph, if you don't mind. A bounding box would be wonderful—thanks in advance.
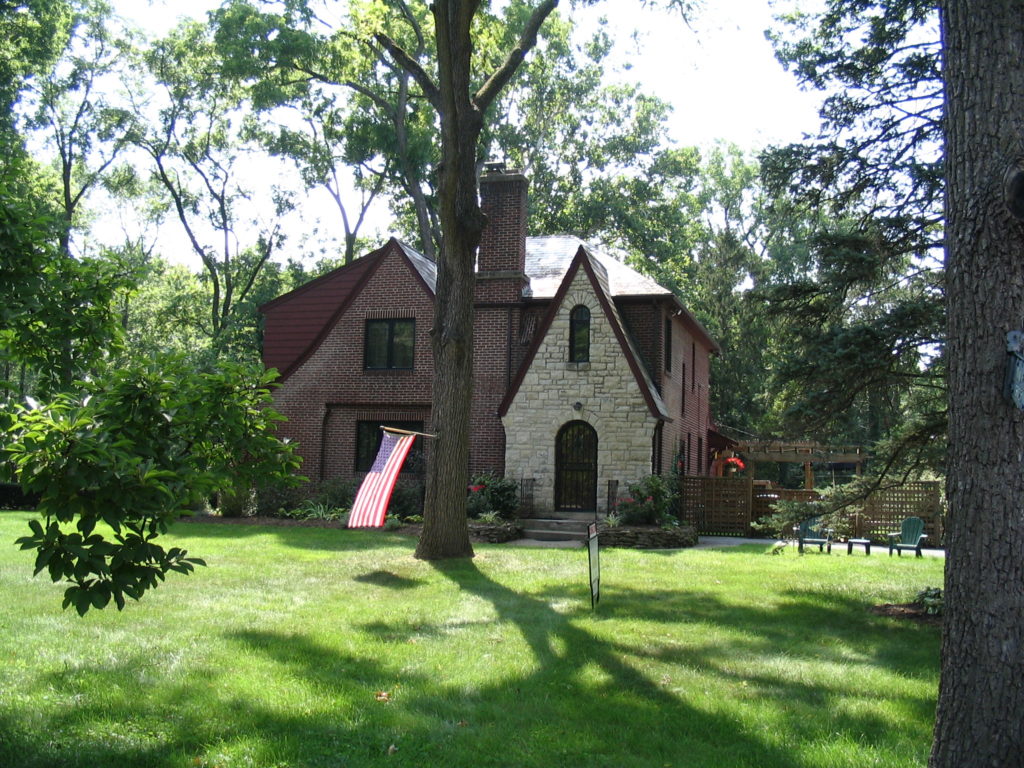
[260,171,718,514]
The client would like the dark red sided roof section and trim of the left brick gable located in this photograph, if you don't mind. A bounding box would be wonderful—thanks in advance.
[259,238,437,378]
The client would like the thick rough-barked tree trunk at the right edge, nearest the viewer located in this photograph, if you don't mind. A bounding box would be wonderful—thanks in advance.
[930,0,1024,768]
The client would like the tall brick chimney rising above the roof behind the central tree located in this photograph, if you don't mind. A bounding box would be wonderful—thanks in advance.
[476,163,529,303]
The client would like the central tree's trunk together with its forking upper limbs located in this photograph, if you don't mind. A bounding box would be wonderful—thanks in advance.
[374,0,696,559]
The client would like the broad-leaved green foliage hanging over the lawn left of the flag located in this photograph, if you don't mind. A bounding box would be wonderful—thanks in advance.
[3,357,298,614]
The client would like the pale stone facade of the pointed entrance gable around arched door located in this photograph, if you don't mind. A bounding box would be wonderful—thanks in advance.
[502,269,658,514]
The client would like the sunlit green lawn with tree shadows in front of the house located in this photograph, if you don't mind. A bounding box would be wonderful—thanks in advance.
[0,513,942,768]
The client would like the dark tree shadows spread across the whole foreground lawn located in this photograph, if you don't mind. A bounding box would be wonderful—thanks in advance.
[0,548,937,768]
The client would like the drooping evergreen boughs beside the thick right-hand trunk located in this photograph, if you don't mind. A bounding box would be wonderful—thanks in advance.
[760,0,945,477]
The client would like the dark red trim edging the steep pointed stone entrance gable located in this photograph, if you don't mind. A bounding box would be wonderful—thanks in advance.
[498,247,672,421]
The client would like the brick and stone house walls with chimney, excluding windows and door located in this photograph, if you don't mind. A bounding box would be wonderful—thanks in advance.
[261,168,715,509]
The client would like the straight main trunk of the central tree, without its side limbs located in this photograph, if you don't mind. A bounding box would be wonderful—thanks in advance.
[416,0,484,560]
